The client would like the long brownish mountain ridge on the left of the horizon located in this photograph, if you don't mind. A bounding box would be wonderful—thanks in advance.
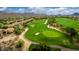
[0,12,46,17]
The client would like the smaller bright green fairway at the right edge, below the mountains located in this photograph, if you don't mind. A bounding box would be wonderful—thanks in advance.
[56,18,79,29]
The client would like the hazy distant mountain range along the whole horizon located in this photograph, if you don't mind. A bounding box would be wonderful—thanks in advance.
[0,11,79,17]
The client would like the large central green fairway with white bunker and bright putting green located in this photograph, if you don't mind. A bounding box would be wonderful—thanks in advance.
[25,20,70,45]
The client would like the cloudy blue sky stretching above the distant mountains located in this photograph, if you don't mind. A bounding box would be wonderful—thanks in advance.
[0,7,79,15]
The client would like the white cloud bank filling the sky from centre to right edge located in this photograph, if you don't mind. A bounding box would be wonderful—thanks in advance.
[29,7,79,15]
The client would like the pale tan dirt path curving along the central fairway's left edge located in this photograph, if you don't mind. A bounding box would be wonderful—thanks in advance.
[19,28,31,51]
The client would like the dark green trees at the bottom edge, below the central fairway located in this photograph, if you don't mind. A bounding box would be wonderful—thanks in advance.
[29,44,61,51]
